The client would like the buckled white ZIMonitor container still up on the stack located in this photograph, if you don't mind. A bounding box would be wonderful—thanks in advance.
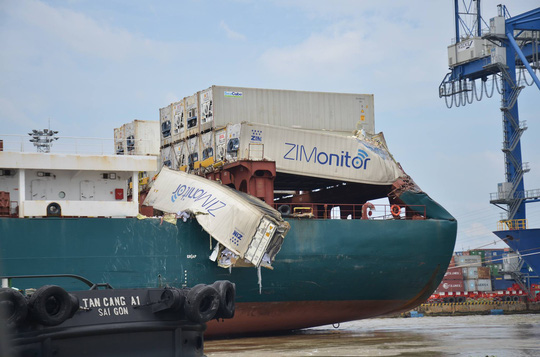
[227,123,403,185]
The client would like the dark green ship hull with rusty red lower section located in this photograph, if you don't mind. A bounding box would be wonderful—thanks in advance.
[0,192,457,336]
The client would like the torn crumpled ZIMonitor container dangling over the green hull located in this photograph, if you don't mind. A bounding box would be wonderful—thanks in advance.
[144,167,289,266]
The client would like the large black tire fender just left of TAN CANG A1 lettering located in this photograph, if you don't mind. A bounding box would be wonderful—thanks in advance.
[28,285,75,326]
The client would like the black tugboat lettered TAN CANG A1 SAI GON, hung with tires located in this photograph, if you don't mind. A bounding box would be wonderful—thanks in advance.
[0,275,236,356]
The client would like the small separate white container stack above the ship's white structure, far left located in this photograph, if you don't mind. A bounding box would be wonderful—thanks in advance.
[114,120,160,156]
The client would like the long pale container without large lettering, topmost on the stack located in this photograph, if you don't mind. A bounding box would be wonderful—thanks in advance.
[200,86,375,134]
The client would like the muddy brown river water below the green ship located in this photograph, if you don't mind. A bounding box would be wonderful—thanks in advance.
[204,314,540,357]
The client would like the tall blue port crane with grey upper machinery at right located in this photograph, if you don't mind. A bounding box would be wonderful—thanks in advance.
[439,0,540,225]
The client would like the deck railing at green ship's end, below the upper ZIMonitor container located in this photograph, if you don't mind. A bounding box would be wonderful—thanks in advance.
[274,202,426,220]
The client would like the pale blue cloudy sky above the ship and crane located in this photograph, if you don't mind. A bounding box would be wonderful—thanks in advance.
[0,0,540,250]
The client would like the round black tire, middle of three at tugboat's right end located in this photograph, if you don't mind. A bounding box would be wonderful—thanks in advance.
[184,284,219,323]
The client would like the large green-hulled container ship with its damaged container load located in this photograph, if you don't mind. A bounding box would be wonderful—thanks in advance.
[0,86,457,336]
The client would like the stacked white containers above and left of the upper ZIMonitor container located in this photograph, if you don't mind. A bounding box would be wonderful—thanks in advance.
[159,86,375,171]
